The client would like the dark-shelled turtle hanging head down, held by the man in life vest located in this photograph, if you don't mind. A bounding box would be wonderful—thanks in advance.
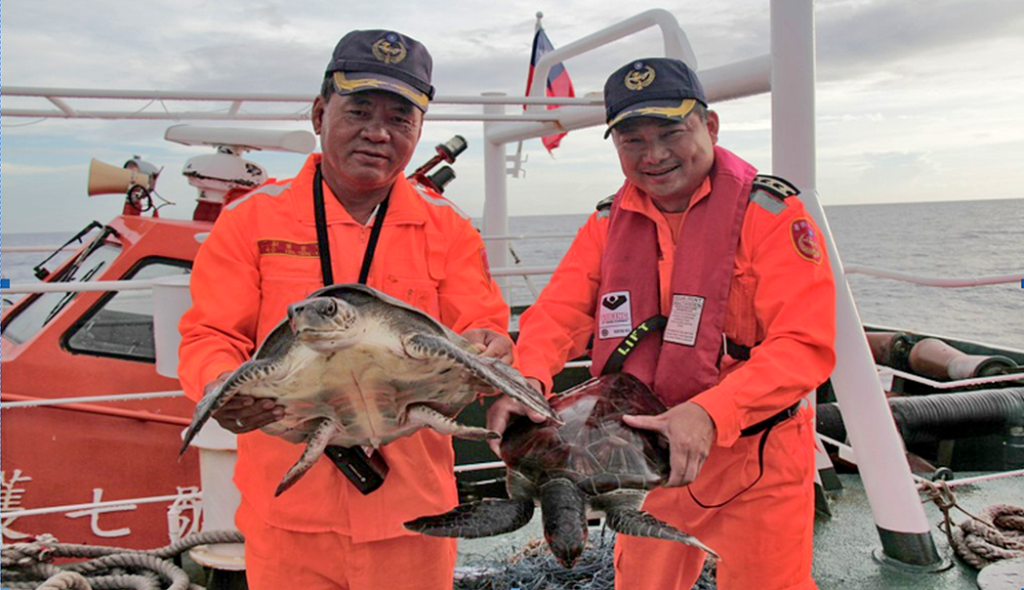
[406,373,718,567]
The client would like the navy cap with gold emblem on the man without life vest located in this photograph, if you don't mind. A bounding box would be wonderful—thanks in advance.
[326,31,434,111]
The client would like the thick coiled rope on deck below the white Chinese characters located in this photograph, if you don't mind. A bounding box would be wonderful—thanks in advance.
[0,531,244,590]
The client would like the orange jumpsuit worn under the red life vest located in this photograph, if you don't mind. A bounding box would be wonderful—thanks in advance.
[517,166,836,590]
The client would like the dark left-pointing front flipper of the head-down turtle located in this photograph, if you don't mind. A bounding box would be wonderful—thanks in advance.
[406,499,534,539]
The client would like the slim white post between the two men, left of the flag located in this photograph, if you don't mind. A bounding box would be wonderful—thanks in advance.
[482,92,512,303]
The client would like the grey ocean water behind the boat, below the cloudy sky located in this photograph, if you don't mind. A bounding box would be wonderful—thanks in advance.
[0,199,1024,349]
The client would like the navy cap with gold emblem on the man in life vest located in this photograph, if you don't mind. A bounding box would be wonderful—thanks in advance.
[604,57,708,137]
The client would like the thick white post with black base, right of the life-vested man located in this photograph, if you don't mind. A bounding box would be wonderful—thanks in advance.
[771,0,943,571]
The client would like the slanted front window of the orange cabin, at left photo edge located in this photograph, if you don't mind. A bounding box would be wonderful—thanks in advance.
[3,244,121,344]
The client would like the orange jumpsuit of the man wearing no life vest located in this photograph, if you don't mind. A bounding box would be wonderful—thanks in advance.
[179,154,509,590]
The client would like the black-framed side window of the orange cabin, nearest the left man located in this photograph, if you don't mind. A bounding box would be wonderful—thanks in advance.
[66,259,190,363]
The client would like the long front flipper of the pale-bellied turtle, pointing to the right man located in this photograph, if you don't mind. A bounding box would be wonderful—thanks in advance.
[403,334,561,424]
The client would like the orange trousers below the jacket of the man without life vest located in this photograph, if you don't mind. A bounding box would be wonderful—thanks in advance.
[234,500,456,590]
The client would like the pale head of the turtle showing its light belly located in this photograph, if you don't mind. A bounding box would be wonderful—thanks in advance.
[288,297,362,350]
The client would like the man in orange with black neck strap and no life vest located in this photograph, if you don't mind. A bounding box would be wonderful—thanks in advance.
[179,31,511,590]
